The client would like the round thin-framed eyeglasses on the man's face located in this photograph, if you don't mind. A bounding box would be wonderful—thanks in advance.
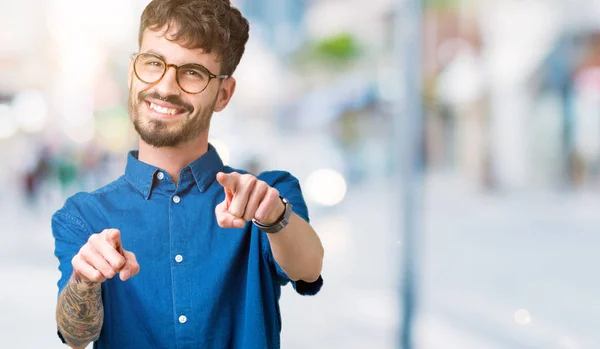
[131,53,229,94]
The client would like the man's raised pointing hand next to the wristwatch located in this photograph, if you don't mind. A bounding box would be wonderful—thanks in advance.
[215,172,285,228]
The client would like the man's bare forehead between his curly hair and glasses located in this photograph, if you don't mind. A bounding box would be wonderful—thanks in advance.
[140,26,220,72]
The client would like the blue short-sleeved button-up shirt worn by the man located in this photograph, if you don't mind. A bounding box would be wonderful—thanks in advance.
[52,145,322,349]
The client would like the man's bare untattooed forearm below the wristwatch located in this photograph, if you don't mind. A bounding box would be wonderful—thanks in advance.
[267,214,324,282]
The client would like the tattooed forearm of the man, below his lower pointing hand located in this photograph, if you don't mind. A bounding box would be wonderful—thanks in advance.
[56,273,104,347]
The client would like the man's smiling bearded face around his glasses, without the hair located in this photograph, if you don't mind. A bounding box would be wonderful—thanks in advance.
[129,25,229,147]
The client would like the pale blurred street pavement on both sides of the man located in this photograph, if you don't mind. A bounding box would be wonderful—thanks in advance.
[0,176,600,349]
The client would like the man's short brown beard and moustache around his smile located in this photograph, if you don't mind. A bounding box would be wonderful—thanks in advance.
[129,91,217,148]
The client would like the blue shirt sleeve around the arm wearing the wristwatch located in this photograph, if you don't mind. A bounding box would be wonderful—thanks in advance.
[253,171,323,296]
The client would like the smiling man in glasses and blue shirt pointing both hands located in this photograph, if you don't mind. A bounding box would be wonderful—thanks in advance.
[52,0,323,349]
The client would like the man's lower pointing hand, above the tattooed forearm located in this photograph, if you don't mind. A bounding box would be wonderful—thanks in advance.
[71,229,140,283]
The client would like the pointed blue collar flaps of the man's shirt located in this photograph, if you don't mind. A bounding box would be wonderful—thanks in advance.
[125,143,223,200]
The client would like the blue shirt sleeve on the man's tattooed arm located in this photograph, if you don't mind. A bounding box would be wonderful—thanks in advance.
[51,210,90,295]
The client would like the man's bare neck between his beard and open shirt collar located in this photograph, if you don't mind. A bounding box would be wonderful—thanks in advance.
[138,132,208,185]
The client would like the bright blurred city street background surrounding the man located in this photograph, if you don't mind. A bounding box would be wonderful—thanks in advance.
[0,0,600,349]
